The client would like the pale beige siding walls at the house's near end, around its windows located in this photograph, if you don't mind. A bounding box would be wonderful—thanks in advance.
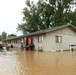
[33,27,76,51]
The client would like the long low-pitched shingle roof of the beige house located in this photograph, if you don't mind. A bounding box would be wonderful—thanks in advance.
[4,23,76,41]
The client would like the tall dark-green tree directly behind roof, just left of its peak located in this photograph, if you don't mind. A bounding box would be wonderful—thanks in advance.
[49,0,75,27]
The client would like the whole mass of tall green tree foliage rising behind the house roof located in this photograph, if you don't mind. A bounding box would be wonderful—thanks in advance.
[17,0,76,34]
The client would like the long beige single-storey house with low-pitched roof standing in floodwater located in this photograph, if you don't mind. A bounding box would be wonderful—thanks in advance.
[2,24,76,51]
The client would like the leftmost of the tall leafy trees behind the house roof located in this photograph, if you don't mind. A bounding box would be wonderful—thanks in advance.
[17,0,39,34]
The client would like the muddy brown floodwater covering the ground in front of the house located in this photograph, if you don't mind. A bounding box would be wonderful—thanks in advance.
[0,50,76,75]
